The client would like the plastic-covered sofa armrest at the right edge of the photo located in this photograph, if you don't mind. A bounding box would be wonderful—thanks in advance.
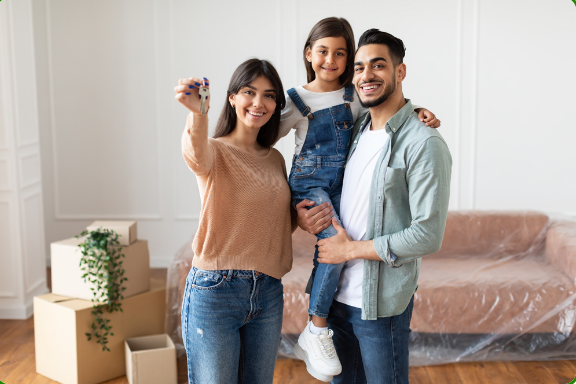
[546,221,576,280]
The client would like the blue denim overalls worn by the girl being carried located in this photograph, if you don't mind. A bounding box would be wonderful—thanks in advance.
[288,85,354,318]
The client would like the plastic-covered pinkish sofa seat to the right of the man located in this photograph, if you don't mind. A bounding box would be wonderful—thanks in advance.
[411,256,576,334]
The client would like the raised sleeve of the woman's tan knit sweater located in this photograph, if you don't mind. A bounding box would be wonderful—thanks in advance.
[182,113,214,176]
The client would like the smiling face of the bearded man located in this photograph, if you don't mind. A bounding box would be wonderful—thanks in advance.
[353,44,404,108]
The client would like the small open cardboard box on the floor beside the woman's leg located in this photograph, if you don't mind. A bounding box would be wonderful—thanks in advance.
[124,334,178,384]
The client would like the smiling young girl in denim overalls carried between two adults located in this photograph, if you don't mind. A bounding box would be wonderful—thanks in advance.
[280,17,439,382]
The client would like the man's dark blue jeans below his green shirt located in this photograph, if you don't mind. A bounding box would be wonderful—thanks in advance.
[328,296,414,384]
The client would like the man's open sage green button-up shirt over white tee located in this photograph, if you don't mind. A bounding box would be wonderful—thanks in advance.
[348,100,452,320]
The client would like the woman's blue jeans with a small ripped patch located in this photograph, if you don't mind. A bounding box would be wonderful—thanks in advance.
[182,267,284,384]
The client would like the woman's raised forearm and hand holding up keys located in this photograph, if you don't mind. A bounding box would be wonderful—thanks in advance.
[174,77,214,176]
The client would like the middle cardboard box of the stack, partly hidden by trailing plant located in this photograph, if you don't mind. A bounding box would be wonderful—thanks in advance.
[50,237,150,300]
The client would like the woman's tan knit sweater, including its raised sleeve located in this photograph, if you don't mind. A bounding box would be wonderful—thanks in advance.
[182,113,296,279]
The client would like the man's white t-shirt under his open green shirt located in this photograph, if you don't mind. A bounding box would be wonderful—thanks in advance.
[334,125,390,308]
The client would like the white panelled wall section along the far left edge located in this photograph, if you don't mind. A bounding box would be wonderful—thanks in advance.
[0,0,47,319]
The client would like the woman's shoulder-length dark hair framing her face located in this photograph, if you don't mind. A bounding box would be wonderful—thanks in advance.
[214,59,286,147]
